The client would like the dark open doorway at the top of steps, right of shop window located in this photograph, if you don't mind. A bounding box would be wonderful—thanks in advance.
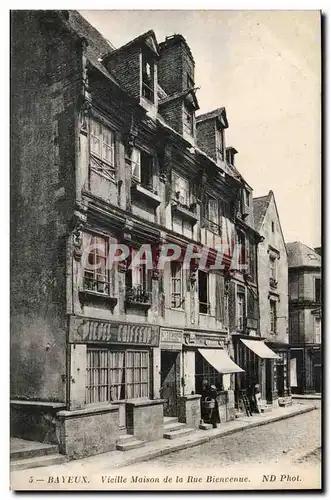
[160,350,180,417]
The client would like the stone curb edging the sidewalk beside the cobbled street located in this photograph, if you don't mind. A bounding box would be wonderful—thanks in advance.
[112,405,318,469]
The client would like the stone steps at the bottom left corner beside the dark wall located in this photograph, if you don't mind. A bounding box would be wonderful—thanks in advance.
[10,438,66,471]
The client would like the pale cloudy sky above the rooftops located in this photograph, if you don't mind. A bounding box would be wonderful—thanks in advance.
[80,10,321,247]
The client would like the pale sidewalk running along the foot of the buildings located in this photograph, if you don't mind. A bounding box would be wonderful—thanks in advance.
[11,403,317,480]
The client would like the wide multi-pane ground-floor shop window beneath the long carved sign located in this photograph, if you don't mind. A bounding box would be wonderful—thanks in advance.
[86,348,149,404]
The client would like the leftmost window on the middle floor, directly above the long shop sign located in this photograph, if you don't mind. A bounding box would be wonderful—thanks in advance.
[84,235,109,294]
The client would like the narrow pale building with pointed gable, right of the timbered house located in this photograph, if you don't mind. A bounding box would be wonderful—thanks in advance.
[253,191,290,403]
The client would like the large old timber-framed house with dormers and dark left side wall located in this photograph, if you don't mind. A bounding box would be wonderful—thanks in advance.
[11,11,273,457]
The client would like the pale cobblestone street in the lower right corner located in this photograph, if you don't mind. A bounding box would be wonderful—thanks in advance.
[122,409,321,473]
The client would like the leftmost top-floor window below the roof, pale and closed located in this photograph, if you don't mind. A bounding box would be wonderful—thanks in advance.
[90,119,115,178]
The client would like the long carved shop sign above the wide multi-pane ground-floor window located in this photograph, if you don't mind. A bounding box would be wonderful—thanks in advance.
[70,317,160,347]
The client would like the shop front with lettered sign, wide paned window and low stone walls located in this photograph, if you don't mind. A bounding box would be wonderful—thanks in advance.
[57,316,163,458]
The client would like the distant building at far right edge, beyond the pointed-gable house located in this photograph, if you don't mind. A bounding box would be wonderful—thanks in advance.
[286,241,322,394]
